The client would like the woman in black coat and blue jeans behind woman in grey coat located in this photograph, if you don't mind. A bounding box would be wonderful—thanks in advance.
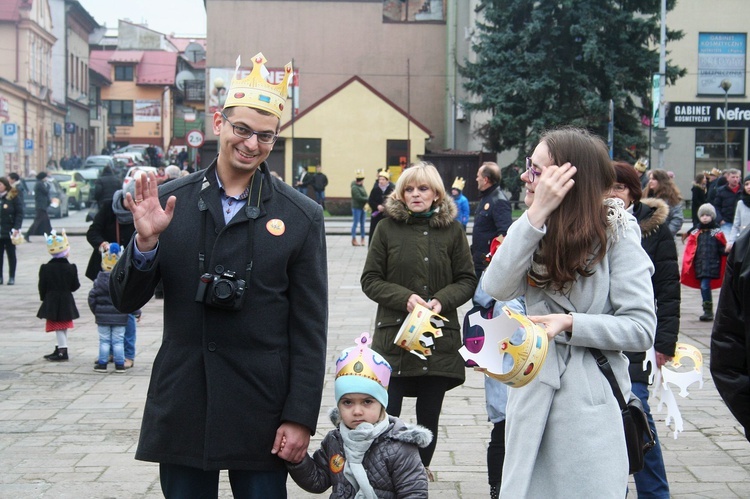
[610,162,680,497]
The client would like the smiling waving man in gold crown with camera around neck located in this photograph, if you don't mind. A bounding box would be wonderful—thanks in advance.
[110,54,328,498]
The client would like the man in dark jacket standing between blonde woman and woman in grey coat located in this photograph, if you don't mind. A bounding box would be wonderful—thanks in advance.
[471,162,513,279]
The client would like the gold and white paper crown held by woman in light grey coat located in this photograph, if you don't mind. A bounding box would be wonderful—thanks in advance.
[458,307,549,388]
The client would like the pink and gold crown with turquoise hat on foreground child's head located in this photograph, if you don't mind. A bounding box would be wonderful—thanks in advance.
[334,333,391,407]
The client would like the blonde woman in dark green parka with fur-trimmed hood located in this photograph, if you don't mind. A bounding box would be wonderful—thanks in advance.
[361,162,477,480]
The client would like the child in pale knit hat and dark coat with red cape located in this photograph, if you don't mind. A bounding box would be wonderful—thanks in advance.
[680,203,727,322]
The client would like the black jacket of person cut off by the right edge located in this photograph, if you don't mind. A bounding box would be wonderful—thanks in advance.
[711,230,750,441]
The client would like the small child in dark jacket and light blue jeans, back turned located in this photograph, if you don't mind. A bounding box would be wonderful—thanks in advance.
[89,243,141,373]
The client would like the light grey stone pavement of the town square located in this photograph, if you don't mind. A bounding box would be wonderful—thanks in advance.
[0,231,750,499]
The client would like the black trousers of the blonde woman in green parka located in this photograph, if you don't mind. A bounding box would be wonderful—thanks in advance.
[386,376,456,466]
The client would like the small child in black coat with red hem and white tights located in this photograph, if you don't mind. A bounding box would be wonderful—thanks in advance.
[36,229,81,362]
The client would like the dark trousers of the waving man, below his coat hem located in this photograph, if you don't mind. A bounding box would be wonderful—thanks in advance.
[159,463,287,499]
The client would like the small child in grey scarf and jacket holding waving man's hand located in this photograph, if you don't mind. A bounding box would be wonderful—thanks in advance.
[282,333,432,499]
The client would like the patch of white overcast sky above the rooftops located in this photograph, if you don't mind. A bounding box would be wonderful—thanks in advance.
[79,0,206,36]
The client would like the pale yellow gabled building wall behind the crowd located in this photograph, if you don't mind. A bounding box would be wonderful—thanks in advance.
[279,81,429,198]
